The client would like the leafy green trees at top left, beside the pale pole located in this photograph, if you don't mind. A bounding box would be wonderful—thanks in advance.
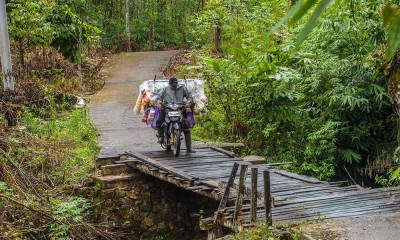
[7,0,100,61]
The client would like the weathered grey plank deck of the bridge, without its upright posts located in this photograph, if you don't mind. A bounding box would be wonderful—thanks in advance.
[110,148,400,230]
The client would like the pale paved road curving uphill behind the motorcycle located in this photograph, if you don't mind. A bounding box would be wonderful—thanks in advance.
[89,51,179,156]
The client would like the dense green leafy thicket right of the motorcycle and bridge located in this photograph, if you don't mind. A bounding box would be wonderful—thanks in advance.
[188,1,396,179]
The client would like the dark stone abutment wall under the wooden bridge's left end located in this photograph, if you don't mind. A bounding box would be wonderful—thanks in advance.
[78,160,218,239]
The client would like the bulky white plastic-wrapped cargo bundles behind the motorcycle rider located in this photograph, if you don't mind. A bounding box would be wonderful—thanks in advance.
[134,79,207,129]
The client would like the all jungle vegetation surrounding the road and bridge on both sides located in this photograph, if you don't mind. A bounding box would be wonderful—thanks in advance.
[0,0,400,239]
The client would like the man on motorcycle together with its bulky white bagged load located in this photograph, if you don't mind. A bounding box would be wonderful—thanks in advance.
[134,77,207,157]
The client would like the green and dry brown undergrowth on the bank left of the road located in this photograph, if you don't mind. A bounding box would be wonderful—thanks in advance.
[0,40,109,239]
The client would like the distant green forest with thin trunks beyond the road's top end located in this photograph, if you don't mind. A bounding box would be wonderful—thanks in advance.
[95,0,198,51]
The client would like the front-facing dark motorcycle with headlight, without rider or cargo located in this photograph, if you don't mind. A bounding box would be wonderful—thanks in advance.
[161,103,185,157]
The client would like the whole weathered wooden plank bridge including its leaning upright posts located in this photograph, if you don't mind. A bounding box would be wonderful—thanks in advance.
[99,147,400,238]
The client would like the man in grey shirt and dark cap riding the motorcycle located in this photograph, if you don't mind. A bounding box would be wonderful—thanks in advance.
[156,77,196,153]
